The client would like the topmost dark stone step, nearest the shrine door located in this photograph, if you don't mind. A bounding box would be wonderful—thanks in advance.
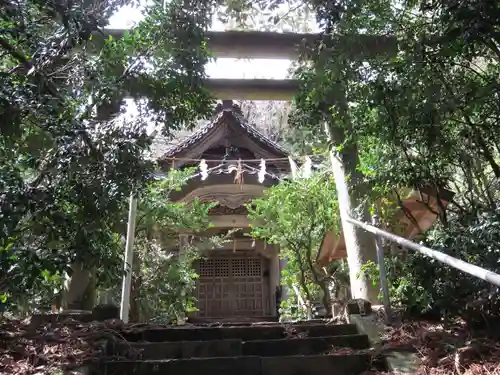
[117,324,358,342]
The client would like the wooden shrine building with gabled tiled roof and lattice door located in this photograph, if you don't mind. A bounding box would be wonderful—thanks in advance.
[159,100,290,320]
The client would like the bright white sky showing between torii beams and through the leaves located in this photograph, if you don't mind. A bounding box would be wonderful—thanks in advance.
[109,6,298,79]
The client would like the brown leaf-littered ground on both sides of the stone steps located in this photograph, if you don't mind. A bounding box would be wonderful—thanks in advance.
[0,319,500,375]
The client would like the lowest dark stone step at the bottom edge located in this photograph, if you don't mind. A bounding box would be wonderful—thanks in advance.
[96,354,371,375]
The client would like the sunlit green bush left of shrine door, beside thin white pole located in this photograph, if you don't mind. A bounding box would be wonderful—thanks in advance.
[124,169,229,322]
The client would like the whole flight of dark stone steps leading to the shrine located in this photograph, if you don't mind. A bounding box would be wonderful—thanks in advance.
[91,322,384,375]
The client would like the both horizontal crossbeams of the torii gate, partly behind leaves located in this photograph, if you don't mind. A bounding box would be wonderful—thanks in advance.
[91,29,397,100]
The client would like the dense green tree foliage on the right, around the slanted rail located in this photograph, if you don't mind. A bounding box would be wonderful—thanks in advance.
[286,0,500,324]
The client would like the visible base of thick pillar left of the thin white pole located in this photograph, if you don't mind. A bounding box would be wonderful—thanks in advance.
[62,262,96,311]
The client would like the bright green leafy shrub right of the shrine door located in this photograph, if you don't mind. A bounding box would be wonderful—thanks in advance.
[248,173,339,318]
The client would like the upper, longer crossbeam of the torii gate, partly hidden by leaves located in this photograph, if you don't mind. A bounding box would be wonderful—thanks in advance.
[90,29,397,60]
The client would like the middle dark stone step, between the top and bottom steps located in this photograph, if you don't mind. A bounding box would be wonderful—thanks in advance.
[112,334,370,360]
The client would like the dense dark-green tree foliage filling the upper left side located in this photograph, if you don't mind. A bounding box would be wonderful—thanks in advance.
[0,1,215,312]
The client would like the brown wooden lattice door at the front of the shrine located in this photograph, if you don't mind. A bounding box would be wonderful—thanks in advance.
[195,251,269,317]
